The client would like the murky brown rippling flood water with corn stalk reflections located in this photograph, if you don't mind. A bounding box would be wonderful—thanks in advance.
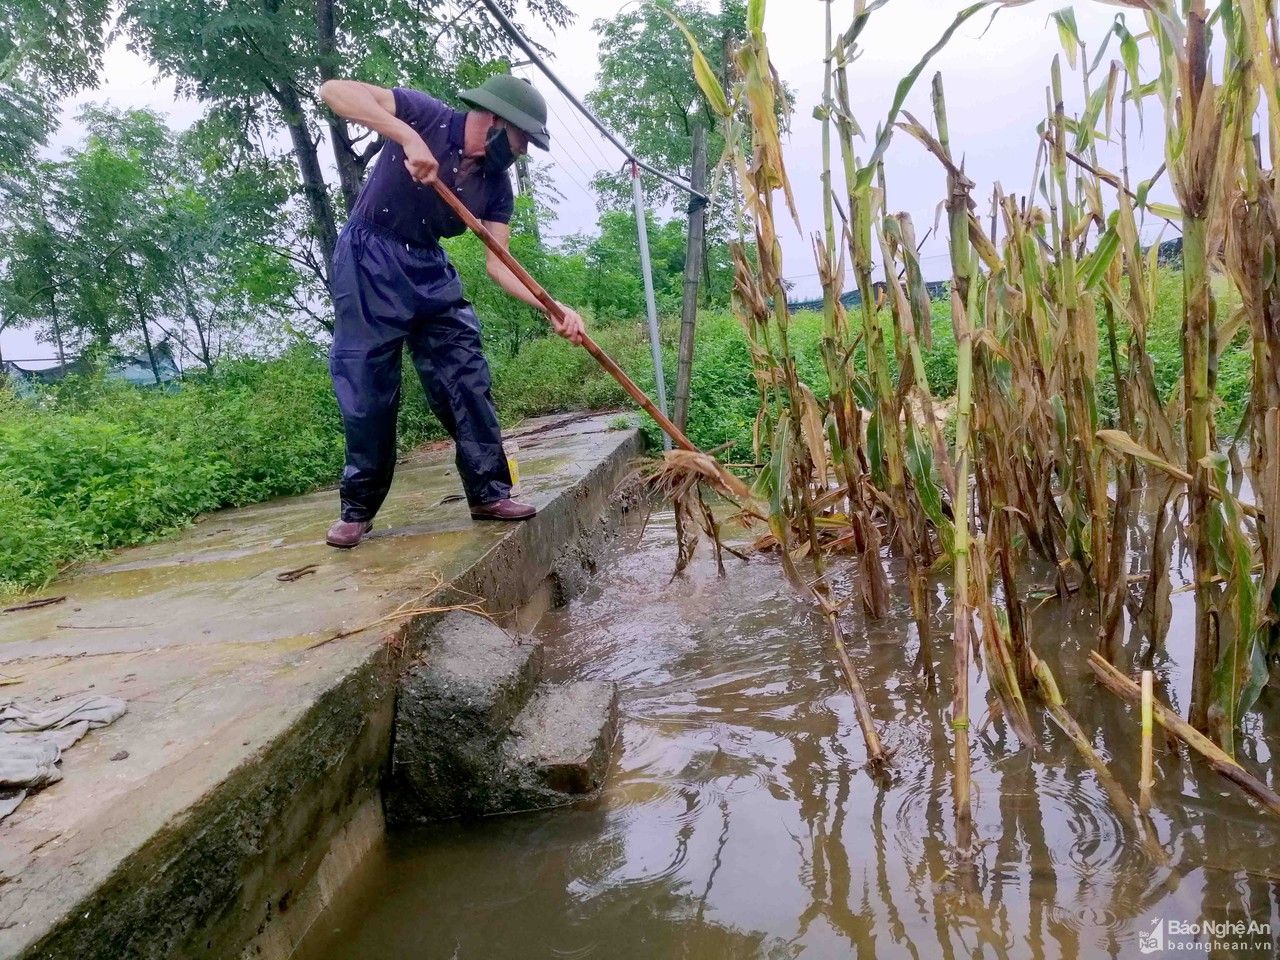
[302,506,1280,960]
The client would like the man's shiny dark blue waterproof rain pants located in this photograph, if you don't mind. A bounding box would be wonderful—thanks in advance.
[329,219,511,520]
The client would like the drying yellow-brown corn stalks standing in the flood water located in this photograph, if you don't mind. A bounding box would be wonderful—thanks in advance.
[666,0,1280,878]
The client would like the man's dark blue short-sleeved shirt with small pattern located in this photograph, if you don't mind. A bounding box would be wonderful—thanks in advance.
[351,87,515,247]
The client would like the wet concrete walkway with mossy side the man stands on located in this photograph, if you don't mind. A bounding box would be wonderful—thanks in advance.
[0,416,640,960]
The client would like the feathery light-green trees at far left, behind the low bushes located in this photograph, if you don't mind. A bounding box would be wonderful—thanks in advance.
[0,108,302,379]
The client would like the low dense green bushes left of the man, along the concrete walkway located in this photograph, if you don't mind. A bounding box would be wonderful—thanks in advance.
[0,349,343,593]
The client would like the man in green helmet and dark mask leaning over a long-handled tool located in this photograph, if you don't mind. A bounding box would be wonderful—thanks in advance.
[320,74,582,548]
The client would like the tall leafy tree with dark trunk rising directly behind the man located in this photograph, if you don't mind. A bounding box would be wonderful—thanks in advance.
[120,0,570,296]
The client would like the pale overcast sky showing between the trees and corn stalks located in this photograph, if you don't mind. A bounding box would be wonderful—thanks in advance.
[0,0,1167,358]
